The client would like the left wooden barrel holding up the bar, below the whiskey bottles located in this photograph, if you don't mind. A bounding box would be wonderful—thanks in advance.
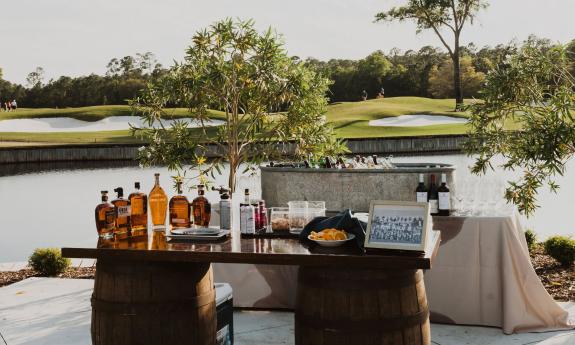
[92,260,217,345]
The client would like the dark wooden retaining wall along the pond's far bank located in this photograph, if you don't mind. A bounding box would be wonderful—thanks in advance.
[0,135,466,163]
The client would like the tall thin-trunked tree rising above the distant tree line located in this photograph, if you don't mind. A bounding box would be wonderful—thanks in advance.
[375,0,487,110]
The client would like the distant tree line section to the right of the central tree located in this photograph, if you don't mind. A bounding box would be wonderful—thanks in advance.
[306,36,575,102]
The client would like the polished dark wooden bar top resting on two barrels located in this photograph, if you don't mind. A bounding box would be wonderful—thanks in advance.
[62,231,440,269]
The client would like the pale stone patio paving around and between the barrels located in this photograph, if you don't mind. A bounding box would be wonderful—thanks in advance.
[0,278,575,345]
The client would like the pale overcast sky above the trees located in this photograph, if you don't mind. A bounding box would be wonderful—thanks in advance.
[0,0,575,83]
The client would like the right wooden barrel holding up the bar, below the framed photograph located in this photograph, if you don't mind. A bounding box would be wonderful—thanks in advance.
[295,267,431,345]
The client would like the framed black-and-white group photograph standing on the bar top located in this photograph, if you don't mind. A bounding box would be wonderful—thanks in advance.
[365,200,431,252]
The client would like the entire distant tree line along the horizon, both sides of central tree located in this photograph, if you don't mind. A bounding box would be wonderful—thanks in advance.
[0,36,575,108]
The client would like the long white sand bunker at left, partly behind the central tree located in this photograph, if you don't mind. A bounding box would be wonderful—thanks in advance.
[0,116,224,133]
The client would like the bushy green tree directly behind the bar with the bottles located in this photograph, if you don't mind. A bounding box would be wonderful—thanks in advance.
[132,19,345,192]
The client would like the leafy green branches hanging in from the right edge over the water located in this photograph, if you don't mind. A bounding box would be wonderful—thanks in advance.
[466,40,575,215]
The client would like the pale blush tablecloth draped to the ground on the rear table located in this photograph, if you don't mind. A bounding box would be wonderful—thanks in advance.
[214,214,575,333]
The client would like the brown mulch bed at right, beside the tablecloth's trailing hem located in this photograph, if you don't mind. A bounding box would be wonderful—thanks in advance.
[531,244,575,302]
